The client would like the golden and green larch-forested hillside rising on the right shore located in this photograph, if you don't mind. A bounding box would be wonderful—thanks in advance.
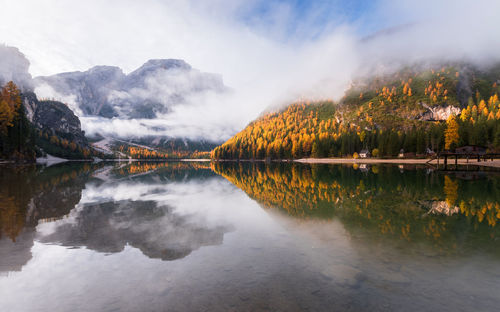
[212,64,500,159]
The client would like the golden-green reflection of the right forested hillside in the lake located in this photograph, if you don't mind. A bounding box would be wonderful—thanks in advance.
[213,163,500,255]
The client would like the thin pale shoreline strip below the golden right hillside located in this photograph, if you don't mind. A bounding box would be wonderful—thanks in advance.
[293,158,500,168]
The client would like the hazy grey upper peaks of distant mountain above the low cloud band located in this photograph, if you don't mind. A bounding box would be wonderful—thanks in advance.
[34,59,226,119]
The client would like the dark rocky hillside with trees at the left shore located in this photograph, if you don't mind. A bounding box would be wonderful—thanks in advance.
[0,81,103,162]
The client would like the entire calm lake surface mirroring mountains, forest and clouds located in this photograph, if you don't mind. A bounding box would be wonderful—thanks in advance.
[0,162,500,312]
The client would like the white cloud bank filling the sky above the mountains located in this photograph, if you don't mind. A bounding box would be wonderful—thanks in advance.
[0,0,500,138]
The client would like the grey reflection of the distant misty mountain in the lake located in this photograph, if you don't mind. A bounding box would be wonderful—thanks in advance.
[40,201,229,260]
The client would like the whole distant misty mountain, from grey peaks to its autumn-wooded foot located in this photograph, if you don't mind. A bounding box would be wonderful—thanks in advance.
[34,59,227,157]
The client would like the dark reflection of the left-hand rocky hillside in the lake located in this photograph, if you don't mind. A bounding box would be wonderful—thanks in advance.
[0,164,97,272]
